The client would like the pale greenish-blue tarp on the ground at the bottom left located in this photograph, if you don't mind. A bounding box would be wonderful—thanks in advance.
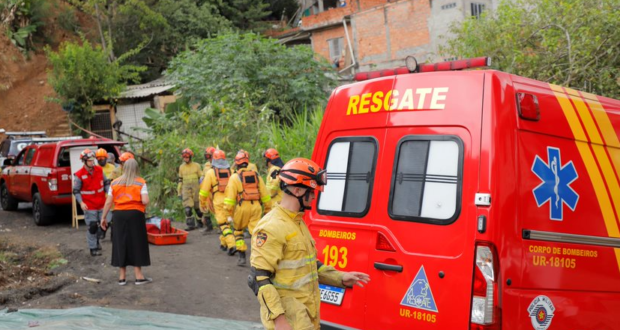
[0,307,263,330]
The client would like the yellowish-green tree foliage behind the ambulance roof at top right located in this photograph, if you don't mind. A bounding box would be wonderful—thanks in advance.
[443,0,620,98]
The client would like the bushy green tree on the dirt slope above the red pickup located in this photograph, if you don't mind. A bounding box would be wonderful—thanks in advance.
[45,39,143,126]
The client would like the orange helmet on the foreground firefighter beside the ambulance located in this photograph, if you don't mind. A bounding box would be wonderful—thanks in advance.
[279,158,327,191]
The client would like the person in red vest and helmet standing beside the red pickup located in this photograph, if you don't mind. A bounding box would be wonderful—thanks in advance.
[73,149,110,257]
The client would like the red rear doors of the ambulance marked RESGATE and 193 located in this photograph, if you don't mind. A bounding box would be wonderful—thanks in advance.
[311,71,484,330]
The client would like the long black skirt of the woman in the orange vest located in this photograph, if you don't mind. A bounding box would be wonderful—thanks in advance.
[112,210,151,267]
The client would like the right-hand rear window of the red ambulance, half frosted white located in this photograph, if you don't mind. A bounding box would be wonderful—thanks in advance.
[389,136,463,225]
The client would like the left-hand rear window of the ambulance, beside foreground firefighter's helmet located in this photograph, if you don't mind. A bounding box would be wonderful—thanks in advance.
[318,137,377,217]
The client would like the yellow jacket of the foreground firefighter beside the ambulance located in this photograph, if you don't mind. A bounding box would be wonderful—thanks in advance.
[250,204,344,329]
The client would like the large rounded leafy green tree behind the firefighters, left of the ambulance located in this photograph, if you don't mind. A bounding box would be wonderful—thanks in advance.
[167,33,335,119]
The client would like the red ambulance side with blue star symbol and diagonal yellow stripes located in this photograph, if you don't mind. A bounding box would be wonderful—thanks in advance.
[504,77,620,330]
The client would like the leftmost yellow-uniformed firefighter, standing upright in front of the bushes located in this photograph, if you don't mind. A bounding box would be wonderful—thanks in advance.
[177,148,202,230]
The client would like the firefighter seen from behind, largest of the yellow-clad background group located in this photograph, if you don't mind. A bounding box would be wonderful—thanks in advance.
[224,151,271,266]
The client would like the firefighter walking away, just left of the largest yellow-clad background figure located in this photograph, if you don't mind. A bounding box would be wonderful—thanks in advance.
[200,150,236,255]
